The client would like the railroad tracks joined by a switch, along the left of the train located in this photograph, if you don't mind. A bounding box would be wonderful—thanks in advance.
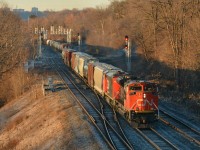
[43,46,177,149]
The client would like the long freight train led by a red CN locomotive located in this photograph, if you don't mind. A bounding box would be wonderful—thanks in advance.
[47,40,159,128]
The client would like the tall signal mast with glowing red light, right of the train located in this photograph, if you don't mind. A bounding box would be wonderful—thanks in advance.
[124,35,131,72]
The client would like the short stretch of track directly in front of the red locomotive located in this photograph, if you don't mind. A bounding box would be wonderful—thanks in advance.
[136,128,178,150]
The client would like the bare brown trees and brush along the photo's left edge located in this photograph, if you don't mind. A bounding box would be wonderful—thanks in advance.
[0,2,33,107]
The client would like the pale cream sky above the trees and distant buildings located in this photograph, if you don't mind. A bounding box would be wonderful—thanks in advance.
[4,0,110,11]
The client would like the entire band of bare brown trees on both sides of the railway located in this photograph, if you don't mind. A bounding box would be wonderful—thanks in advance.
[0,0,200,105]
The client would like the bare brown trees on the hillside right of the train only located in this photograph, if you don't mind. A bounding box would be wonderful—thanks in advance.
[30,0,200,94]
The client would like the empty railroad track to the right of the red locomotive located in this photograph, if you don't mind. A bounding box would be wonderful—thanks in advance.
[160,109,200,147]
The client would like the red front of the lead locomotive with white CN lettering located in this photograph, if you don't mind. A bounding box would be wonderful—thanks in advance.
[124,81,159,124]
